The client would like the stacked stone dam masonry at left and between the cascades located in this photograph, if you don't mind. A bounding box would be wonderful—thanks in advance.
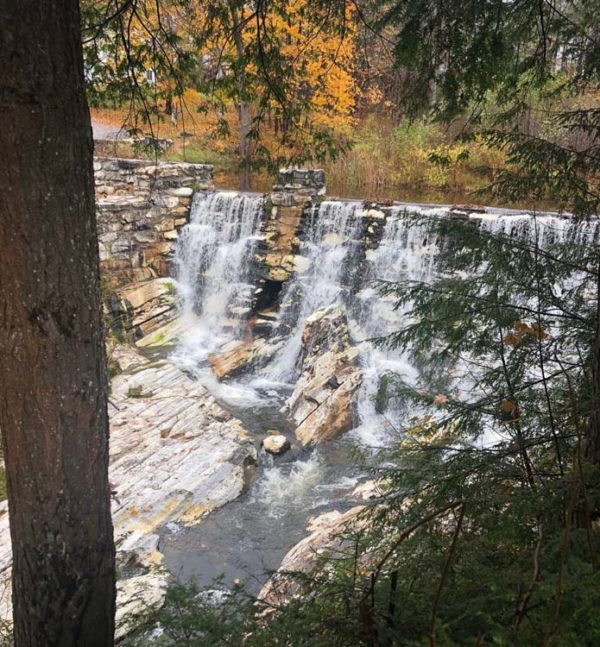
[95,158,386,338]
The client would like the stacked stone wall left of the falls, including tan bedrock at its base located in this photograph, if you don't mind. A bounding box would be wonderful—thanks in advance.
[94,158,213,339]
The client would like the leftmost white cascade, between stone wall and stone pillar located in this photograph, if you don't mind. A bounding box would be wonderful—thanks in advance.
[175,192,264,362]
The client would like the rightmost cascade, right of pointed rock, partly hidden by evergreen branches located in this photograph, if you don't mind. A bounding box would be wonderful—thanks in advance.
[351,207,599,446]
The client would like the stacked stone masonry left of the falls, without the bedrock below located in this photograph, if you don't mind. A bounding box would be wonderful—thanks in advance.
[94,158,213,287]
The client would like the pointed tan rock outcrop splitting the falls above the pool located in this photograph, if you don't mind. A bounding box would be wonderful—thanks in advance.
[284,307,362,445]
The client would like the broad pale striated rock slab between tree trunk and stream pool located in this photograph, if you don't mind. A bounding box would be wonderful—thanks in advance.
[110,361,256,550]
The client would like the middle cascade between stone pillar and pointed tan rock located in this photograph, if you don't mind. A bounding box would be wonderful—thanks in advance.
[268,201,362,381]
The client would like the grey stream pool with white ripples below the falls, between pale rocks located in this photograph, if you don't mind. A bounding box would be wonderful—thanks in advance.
[160,438,367,594]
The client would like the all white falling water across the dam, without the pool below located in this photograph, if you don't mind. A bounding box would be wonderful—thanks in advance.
[171,192,598,447]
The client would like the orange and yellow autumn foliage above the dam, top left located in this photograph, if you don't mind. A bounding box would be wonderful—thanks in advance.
[83,0,358,177]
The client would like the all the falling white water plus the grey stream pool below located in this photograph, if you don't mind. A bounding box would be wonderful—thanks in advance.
[163,193,599,590]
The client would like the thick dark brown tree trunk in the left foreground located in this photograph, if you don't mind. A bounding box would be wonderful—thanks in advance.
[0,0,115,647]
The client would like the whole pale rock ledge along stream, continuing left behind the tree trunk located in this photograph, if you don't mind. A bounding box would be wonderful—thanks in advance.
[0,350,256,639]
